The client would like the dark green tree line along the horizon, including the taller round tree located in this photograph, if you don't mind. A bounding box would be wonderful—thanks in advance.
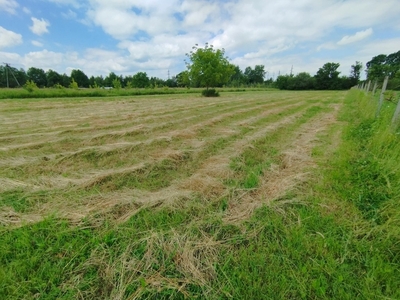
[0,49,400,90]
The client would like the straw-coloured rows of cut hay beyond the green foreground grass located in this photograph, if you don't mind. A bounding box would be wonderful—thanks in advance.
[0,92,340,225]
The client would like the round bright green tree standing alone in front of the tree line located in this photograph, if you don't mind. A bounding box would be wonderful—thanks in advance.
[186,43,234,90]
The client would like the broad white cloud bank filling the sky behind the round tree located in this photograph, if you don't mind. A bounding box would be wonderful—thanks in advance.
[0,0,400,78]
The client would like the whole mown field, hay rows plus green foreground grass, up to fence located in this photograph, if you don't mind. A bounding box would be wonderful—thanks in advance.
[0,91,400,299]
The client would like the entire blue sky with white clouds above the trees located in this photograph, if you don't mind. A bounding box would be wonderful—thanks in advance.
[0,0,400,79]
